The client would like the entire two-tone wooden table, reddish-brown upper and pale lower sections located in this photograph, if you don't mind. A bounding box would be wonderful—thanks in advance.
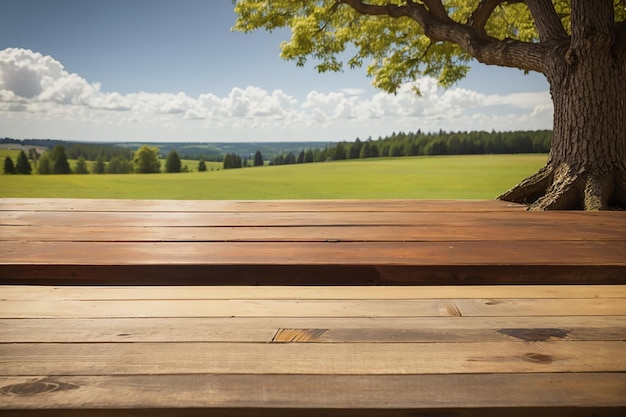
[0,199,626,417]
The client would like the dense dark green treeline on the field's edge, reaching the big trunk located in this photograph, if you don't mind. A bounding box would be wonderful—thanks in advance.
[271,130,552,165]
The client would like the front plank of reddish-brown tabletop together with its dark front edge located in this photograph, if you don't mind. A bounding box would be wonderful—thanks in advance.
[0,241,626,285]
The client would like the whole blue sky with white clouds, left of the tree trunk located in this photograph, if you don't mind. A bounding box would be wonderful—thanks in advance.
[0,0,552,142]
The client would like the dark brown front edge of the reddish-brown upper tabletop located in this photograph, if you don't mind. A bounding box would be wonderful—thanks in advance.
[6,263,626,286]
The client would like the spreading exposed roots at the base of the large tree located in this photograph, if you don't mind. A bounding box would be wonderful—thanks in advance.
[498,164,626,211]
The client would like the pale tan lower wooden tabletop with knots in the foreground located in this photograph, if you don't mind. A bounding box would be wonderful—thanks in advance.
[0,285,626,416]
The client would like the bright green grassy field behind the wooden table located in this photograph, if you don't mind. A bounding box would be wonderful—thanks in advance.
[0,154,546,200]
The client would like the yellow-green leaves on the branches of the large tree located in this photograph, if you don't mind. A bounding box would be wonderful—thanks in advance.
[233,0,626,93]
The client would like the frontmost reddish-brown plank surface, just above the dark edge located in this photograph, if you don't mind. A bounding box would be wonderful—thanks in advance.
[0,240,626,264]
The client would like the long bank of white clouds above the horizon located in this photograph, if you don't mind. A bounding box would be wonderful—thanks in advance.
[0,48,552,141]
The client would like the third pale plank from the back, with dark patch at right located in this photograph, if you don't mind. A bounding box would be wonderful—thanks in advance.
[0,316,626,343]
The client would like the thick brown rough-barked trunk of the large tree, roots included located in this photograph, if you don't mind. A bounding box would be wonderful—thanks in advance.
[499,0,626,210]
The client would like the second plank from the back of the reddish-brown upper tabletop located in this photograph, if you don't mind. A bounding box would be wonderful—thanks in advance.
[0,211,626,229]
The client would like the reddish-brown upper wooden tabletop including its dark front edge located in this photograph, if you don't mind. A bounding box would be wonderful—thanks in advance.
[0,199,626,285]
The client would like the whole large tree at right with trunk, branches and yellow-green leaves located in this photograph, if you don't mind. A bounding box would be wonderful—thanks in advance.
[234,0,626,210]
